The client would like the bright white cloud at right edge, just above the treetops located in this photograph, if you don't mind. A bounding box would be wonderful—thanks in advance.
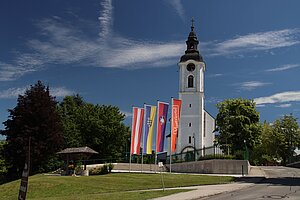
[254,91,300,104]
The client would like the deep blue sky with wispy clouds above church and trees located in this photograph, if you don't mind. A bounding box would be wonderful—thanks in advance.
[0,0,300,139]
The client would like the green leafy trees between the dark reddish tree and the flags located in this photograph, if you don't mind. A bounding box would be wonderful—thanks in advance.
[58,95,130,158]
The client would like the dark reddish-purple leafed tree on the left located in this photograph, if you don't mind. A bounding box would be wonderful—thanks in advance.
[1,81,63,178]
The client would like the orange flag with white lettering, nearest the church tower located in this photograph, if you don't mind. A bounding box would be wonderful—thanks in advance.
[171,99,181,153]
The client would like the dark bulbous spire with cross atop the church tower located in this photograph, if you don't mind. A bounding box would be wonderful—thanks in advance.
[180,18,203,62]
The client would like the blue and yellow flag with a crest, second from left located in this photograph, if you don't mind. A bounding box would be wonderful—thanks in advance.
[143,105,156,154]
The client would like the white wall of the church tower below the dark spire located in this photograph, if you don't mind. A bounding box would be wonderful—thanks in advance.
[176,60,205,153]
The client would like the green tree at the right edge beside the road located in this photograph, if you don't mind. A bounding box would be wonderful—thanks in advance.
[272,114,300,165]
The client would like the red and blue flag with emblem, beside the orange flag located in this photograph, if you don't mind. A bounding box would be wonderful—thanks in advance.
[156,101,169,152]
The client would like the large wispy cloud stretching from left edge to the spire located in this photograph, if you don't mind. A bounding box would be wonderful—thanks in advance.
[0,0,185,81]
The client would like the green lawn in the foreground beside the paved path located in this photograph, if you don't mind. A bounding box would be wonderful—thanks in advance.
[0,173,233,200]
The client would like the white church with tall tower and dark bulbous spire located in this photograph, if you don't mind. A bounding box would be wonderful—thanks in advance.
[176,20,215,156]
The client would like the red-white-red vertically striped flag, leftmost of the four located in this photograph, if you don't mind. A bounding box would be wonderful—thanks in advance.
[130,107,144,154]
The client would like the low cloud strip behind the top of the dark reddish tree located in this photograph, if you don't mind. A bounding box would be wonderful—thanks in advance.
[0,86,74,99]
